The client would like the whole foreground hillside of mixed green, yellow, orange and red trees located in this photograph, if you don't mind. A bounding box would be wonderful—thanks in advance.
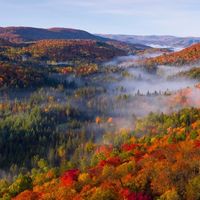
[1,109,200,200]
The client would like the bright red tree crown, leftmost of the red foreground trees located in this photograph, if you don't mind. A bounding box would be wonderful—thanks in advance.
[60,169,80,186]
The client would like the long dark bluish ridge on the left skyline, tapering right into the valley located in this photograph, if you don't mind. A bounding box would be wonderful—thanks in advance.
[0,27,150,54]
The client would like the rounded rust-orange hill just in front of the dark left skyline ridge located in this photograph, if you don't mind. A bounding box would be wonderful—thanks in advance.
[10,40,127,62]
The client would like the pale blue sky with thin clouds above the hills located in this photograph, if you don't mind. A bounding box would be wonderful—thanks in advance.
[0,0,200,36]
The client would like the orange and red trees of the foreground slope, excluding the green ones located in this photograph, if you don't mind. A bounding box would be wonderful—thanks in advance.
[12,110,200,200]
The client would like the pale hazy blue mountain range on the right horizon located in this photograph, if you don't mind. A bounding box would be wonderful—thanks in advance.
[98,34,200,47]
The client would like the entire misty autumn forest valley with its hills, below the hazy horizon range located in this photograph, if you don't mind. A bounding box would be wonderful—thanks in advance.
[0,27,200,200]
